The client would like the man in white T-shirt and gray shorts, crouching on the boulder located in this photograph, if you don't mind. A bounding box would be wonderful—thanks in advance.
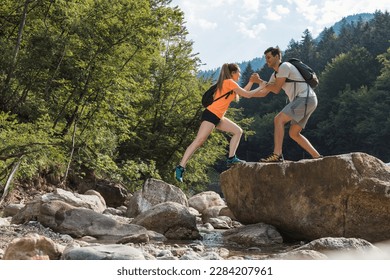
[251,47,322,162]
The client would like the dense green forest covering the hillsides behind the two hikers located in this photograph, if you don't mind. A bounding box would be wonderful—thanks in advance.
[0,0,390,193]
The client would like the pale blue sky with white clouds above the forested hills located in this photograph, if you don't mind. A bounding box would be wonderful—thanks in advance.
[171,0,390,70]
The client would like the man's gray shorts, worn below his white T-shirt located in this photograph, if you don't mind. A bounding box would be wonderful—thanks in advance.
[282,96,318,128]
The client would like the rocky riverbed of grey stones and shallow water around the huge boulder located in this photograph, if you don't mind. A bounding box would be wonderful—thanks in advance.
[0,153,390,260]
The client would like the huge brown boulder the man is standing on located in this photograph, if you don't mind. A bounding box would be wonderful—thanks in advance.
[221,153,390,242]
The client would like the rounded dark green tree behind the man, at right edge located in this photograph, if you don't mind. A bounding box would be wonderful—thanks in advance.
[313,48,389,159]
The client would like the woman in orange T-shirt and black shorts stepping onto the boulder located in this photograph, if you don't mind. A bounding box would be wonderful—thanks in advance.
[175,63,260,182]
